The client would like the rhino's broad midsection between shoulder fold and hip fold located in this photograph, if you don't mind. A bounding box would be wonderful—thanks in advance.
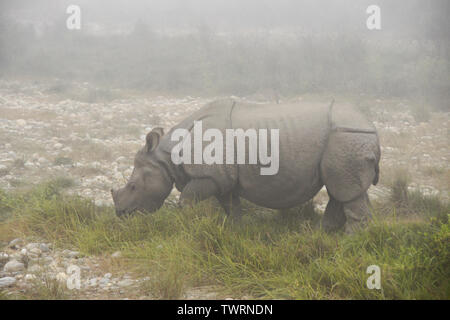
[232,103,329,208]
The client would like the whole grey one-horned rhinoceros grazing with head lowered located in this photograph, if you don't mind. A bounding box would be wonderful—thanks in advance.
[111,99,380,232]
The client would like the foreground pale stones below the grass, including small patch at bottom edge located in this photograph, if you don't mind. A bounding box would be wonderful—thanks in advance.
[0,238,225,300]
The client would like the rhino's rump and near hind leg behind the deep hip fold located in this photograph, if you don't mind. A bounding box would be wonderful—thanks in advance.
[320,132,379,233]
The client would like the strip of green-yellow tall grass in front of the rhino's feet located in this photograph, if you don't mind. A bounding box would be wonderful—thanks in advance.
[0,183,450,299]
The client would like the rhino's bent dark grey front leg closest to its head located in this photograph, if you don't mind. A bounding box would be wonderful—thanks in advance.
[180,178,219,206]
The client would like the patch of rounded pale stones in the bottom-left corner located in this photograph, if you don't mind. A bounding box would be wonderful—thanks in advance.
[0,238,141,299]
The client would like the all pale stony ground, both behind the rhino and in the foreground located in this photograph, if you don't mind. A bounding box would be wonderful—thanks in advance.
[0,80,450,299]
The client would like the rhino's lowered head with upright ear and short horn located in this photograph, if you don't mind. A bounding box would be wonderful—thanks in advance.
[111,128,173,216]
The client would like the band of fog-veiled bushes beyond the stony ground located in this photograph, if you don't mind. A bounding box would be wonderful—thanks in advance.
[0,17,450,104]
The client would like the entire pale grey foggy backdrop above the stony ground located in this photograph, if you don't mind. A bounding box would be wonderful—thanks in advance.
[0,0,450,111]
